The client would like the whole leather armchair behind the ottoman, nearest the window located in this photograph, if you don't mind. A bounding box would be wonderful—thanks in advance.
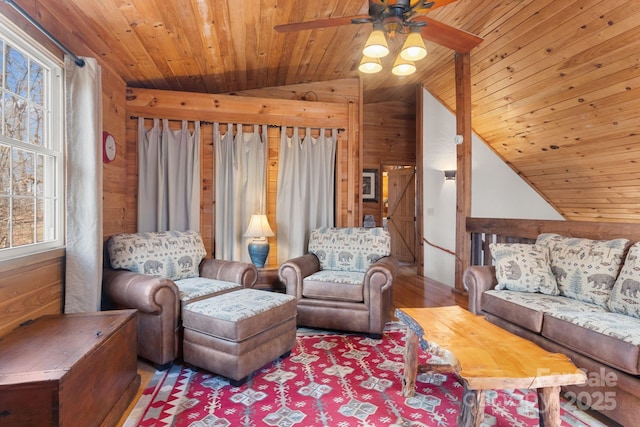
[102,231,258,369]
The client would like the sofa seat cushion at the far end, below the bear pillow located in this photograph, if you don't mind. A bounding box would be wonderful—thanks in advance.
[482,290,606,333]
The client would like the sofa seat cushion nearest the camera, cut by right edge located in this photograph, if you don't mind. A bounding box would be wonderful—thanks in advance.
[542,310,640,375]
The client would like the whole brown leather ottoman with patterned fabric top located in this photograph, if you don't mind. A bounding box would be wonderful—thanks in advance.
[182,289,297,385]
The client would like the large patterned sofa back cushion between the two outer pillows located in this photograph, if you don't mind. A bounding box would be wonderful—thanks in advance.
[536,233,630,308]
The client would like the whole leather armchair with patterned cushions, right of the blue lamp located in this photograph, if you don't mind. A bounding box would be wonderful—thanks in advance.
[279,227,398,336]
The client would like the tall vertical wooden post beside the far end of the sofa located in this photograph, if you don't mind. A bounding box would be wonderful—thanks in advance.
[453,52,471,293]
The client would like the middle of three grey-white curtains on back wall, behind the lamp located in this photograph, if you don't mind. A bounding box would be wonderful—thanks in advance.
[213,123,267,262]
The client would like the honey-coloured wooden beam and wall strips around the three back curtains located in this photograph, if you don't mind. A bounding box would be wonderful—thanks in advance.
[125,79,361,264]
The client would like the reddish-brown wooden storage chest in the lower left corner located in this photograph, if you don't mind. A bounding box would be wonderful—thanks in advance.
[0,310,140,427]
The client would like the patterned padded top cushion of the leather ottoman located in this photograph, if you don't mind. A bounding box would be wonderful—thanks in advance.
[182,289,297,342]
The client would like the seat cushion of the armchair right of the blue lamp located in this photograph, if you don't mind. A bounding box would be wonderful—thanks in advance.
[302,270,364,302]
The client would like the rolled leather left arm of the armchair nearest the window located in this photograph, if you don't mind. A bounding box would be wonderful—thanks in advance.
[102,269,180,367]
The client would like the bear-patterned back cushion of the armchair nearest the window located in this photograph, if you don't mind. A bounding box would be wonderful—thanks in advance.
[107,231,207,280]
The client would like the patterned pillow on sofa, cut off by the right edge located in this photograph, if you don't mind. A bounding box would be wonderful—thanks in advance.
[608,242,640,318]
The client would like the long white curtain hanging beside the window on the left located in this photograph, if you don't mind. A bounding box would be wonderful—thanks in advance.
[64,56,103,313]
